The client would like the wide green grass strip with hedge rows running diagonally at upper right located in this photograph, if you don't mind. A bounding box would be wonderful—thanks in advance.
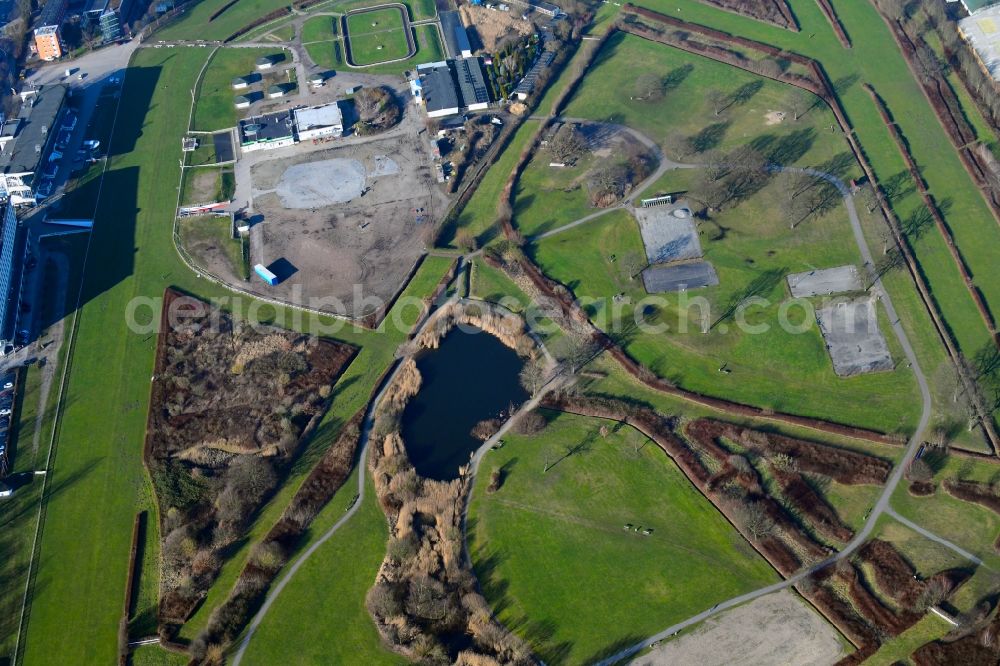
[624,0,1000,374]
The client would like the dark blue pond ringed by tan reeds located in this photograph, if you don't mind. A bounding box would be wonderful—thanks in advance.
[403,327,528,481]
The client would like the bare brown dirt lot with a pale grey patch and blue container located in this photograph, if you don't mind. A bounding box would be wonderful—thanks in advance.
[250,132,447,317]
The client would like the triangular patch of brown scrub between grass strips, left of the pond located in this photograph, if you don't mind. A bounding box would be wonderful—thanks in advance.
[144,290,355,638]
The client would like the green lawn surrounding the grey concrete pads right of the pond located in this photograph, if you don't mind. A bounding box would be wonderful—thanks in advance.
[529,180,919,433]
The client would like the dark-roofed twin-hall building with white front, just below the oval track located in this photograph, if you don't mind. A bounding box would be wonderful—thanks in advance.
[410,58,490,118]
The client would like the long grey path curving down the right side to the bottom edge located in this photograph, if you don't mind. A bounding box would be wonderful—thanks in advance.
[600,162,936,666]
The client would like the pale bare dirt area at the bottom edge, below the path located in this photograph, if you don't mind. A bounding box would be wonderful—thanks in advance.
[632,590,843,666]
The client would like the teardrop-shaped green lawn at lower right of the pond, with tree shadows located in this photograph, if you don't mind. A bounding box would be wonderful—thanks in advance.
[469,413,777,664]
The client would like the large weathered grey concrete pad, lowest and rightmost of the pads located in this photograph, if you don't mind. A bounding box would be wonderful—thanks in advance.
[816,298,893,377]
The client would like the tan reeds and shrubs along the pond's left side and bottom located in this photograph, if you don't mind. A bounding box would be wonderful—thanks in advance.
[366,368,533,664]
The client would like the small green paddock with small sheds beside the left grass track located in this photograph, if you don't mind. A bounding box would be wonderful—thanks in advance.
[193,48,291,132]
